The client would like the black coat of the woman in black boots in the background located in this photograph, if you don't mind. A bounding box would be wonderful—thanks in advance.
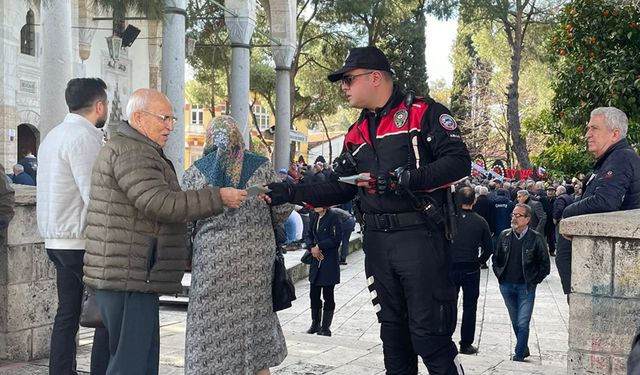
[306,208,342,286]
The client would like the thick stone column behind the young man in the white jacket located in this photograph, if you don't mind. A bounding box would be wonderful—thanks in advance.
[38,0,73,139]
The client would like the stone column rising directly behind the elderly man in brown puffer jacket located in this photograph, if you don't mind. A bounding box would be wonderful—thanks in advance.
[162,0,187,180]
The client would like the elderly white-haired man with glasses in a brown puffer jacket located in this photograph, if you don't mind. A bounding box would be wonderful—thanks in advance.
[84,89,246,375]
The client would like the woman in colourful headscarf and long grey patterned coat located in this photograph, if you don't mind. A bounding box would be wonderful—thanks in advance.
[183,116,293,375]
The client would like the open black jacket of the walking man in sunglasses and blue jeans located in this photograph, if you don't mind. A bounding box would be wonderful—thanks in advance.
[493,229,550,286]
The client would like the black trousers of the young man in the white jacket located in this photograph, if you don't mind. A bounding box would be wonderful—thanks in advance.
[47,249,109,375]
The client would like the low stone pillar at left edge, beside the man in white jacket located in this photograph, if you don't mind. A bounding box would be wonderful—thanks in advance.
[0,185,58,361]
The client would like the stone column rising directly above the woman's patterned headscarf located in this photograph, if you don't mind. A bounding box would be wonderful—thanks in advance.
[224,0,256,149]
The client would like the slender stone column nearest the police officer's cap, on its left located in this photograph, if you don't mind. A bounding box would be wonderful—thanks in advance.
[273,45,295,170]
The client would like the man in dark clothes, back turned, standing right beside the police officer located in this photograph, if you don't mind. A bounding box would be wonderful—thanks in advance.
[451,187,493,354]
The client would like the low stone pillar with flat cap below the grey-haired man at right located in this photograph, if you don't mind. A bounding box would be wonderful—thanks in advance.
[560,210,640,375]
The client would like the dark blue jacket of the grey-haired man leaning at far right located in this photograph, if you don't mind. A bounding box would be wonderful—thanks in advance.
[563,139,640,217]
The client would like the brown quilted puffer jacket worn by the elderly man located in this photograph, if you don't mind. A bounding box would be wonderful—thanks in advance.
[84,123,223,294]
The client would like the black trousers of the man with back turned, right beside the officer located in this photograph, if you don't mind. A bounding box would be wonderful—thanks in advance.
[451,268,480,347]
